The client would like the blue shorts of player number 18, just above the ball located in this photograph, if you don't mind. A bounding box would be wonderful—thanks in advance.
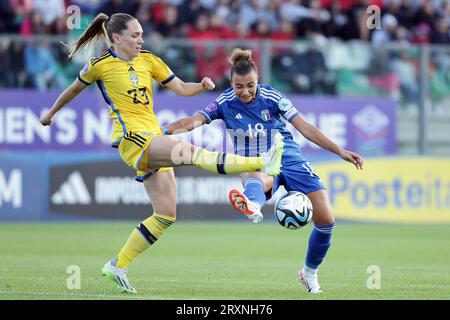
[266,157,325,200]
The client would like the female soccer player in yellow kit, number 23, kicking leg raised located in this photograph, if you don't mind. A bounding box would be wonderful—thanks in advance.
[41,13,284,293]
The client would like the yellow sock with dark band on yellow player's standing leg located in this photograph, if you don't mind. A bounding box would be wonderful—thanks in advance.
[116,212,175,268]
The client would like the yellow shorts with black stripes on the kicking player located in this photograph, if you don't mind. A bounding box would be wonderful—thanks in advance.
[117,131,173,182]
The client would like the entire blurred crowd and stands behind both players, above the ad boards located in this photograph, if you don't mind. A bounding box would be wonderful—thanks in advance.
[0,0,450,109]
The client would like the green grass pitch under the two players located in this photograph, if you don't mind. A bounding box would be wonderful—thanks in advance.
[0,220,450,300]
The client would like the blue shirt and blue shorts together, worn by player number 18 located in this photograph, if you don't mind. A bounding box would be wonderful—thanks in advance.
[200,84,325,198]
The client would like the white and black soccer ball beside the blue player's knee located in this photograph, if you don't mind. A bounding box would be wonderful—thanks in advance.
[275,191,313,230]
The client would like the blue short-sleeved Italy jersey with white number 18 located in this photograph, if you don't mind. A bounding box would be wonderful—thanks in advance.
[200,84,303,158]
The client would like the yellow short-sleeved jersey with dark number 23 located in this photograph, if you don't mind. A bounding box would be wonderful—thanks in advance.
[78,48,175,146]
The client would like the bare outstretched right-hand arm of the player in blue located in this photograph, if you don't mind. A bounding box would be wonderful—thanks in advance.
[291,115,364,169]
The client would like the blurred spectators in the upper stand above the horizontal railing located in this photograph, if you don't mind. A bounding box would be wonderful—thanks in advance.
[0,0,450,45]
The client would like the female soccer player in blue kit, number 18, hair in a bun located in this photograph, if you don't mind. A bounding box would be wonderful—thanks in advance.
[164,49,364,293]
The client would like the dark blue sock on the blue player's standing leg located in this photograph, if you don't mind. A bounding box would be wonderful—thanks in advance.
[305,223,334,269]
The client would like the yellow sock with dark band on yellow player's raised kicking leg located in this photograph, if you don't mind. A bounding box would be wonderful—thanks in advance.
[192,148,264,174]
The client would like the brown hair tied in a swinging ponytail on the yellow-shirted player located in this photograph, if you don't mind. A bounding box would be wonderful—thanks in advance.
[67,13,136,58]
